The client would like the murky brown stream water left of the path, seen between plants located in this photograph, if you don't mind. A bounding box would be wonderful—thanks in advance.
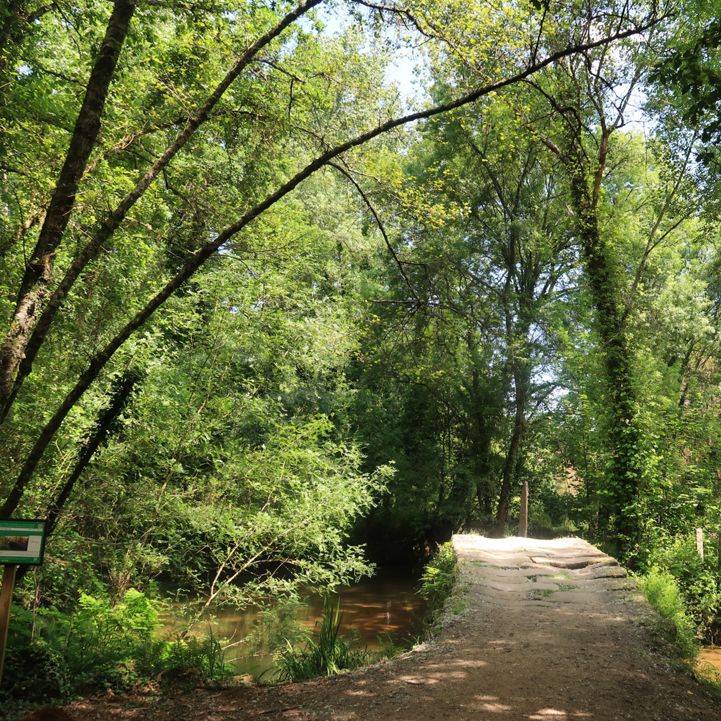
[166,572,426,681]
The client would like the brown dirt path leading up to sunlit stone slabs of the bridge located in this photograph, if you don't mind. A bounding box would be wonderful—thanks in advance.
[68,535,721,721]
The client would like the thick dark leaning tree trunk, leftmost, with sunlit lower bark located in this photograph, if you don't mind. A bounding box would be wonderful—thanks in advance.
[0,0,135,417]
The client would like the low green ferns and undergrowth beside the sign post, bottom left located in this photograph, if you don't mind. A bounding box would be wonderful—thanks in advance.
[0,589,227,701]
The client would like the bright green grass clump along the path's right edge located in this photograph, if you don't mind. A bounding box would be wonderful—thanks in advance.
[640,567,699,658]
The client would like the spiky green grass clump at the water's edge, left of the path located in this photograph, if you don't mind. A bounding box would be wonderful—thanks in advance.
[277,596,370,681]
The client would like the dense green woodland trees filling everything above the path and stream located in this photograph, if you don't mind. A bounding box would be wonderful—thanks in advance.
[0,0,721,688]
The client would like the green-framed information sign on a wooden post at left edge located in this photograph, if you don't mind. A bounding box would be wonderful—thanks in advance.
[0,520,45,683]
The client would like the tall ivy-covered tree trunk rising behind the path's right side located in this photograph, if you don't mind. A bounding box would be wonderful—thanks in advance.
[506,8,664,555]
